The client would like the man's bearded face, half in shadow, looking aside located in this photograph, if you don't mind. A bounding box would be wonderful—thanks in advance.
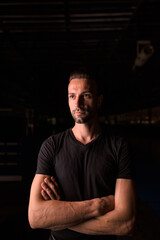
[68,78,100,123]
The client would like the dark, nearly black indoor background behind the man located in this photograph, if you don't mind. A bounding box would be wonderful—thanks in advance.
[0,0,160,240]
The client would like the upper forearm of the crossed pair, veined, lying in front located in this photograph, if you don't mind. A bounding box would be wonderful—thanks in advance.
[29,199,106,230]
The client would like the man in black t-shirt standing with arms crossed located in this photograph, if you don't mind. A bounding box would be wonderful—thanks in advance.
[28,71,136,240]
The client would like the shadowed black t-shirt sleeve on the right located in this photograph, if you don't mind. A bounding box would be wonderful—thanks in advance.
[117,139,134,179]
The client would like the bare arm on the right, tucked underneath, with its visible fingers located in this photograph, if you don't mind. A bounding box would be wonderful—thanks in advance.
[42,179,136,235]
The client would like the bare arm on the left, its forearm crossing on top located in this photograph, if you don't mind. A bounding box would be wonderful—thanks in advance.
[28,174,114,230]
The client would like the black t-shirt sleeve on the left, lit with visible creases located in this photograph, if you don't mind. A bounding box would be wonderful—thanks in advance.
[36,137,55,175]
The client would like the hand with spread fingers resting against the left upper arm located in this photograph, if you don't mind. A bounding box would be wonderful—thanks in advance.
[41,176,61,200]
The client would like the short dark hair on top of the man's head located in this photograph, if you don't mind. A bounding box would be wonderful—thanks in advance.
[69,69,103,95]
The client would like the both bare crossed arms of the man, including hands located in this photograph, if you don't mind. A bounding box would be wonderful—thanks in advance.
[28,174,136,235]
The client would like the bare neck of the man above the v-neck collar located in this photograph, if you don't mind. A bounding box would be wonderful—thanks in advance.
[72,118,100,144]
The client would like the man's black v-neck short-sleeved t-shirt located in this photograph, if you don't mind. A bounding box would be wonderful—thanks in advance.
[36,129,132,240]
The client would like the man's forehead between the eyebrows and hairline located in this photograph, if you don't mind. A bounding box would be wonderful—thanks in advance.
[68,78,97,92]
